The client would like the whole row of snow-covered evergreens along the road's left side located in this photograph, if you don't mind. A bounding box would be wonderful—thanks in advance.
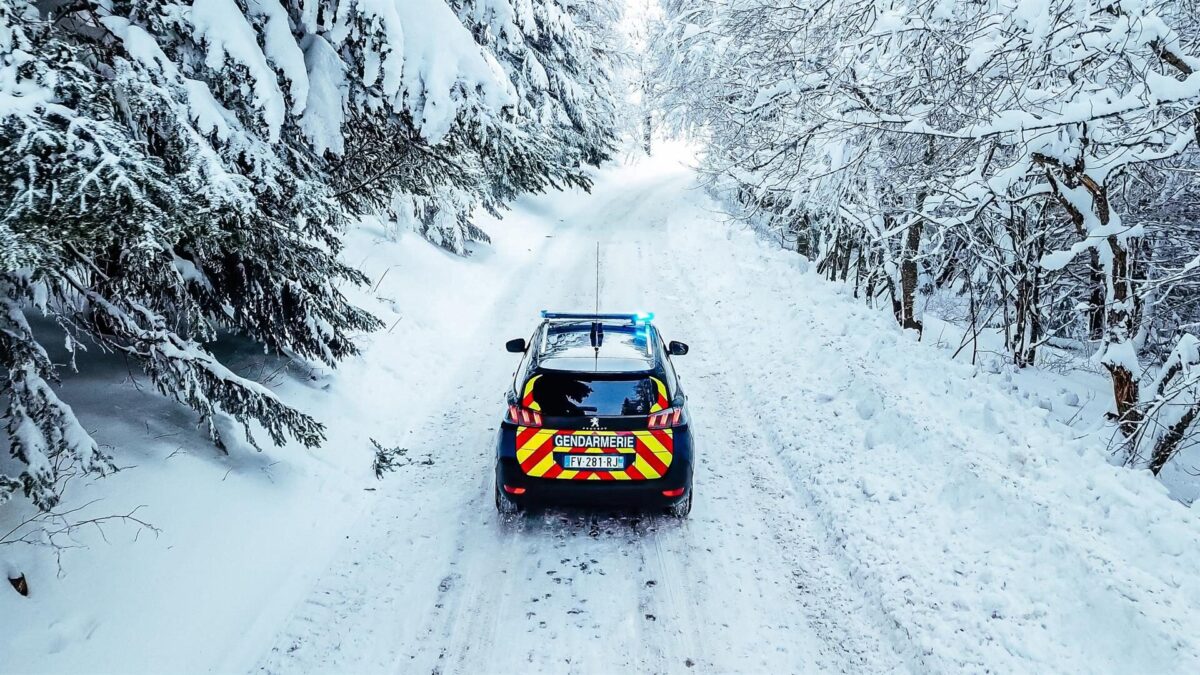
[7,0,628,509]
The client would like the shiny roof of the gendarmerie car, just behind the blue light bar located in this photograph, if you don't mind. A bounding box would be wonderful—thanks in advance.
[536,321,659,372]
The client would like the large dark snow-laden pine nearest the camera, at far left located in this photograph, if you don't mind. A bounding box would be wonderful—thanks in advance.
[0,0,377,509]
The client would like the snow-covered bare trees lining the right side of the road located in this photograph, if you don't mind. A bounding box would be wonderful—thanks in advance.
[654,0,1200,468]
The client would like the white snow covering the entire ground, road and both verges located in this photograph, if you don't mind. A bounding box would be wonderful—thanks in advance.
[0,141,1200,673]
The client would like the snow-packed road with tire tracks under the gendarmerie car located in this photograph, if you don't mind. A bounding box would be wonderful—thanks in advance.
[253,158,906,673]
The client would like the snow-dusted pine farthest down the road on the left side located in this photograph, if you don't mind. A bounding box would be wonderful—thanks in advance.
[379,0,619,253]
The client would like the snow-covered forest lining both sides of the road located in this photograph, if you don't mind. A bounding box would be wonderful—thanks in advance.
[0,0,1200,578]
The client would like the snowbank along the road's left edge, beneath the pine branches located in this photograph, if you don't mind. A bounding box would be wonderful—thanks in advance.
[0,198,544,673]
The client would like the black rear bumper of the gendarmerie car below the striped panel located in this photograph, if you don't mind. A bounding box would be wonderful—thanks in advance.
[496,456,691,507]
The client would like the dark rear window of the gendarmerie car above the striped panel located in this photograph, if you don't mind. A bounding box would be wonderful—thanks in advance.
[533,372,655,417]
